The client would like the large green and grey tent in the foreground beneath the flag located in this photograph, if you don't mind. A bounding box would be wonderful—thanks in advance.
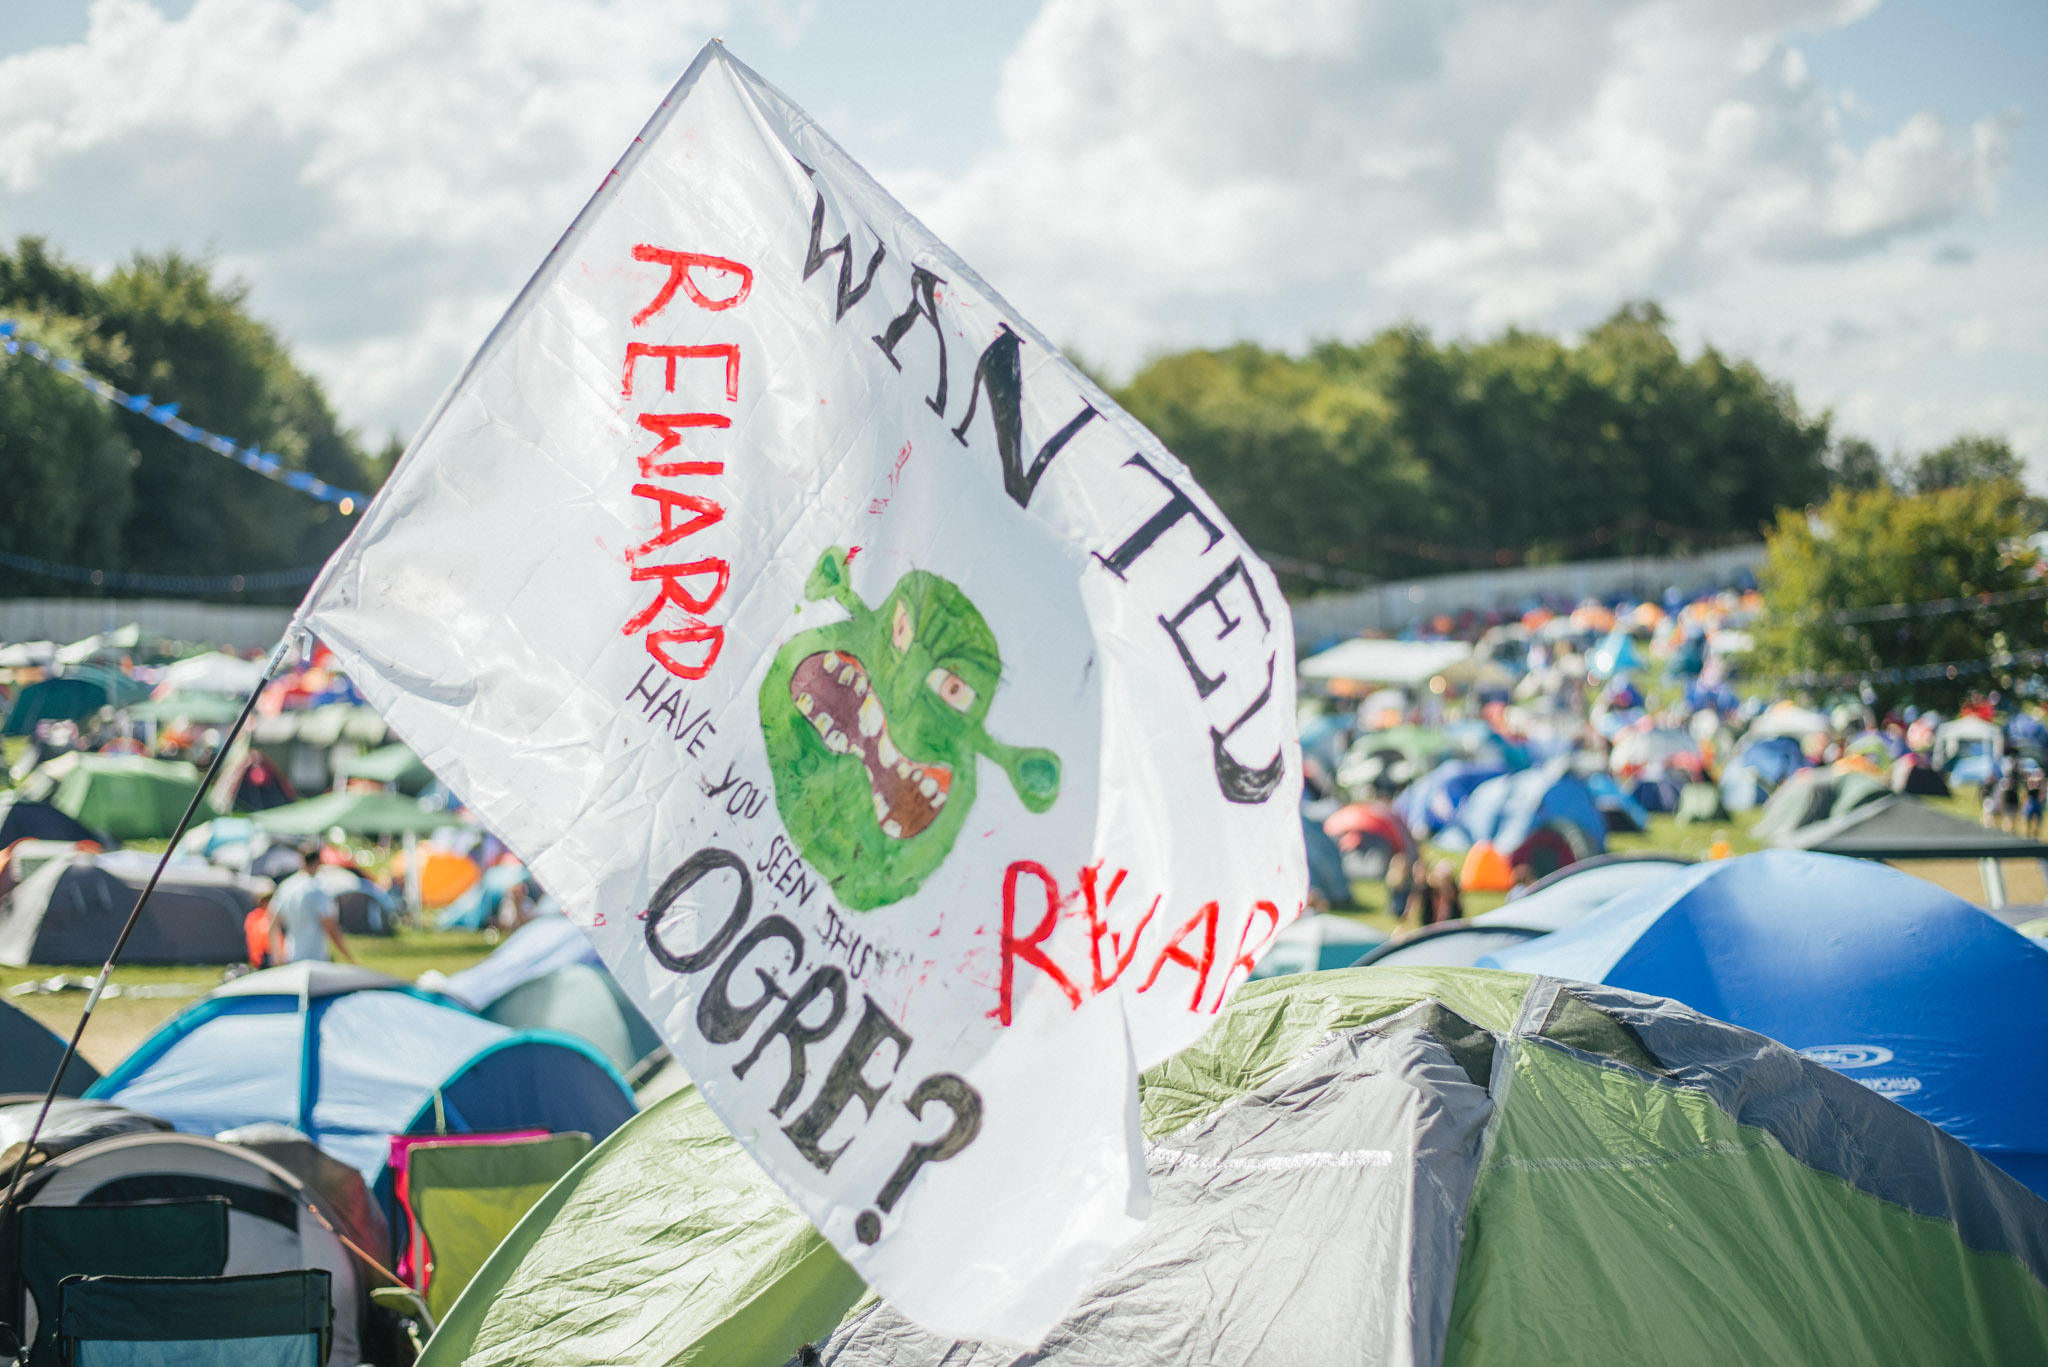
[422,967,2048,1367]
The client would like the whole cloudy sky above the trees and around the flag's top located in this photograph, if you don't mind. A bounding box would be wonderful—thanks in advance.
[0,0,2048,473]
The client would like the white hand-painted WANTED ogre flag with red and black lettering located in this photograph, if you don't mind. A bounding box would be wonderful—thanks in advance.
[303,45,1307,1342]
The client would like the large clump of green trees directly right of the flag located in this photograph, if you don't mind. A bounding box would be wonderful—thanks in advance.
[1118,303,1829,586]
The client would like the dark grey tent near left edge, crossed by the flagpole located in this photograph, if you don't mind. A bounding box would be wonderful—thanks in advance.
[0,855,258,967]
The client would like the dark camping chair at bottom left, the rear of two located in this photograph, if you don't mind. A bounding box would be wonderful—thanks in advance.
[10,1197,227,1367]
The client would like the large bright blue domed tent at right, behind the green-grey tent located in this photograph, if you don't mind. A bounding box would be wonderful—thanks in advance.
[1481,851,2048,1195]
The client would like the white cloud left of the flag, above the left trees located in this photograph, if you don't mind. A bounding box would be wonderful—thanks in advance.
[0,0,729,428]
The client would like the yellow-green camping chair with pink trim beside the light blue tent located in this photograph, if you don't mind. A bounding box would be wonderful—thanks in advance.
[401,1133,590,1322]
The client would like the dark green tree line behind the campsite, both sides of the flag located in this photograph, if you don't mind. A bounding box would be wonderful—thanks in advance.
[0,238,2038,600]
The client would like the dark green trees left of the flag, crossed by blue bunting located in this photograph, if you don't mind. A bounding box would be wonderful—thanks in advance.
[0,238,397,603]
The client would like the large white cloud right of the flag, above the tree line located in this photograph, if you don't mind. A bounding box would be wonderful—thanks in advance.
[909,0,2048,457]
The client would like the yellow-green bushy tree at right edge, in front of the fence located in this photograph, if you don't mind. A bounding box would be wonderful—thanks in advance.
[1757,480,2048,709]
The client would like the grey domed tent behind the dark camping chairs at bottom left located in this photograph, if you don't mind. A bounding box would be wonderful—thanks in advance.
[6,1133,371,1367]
